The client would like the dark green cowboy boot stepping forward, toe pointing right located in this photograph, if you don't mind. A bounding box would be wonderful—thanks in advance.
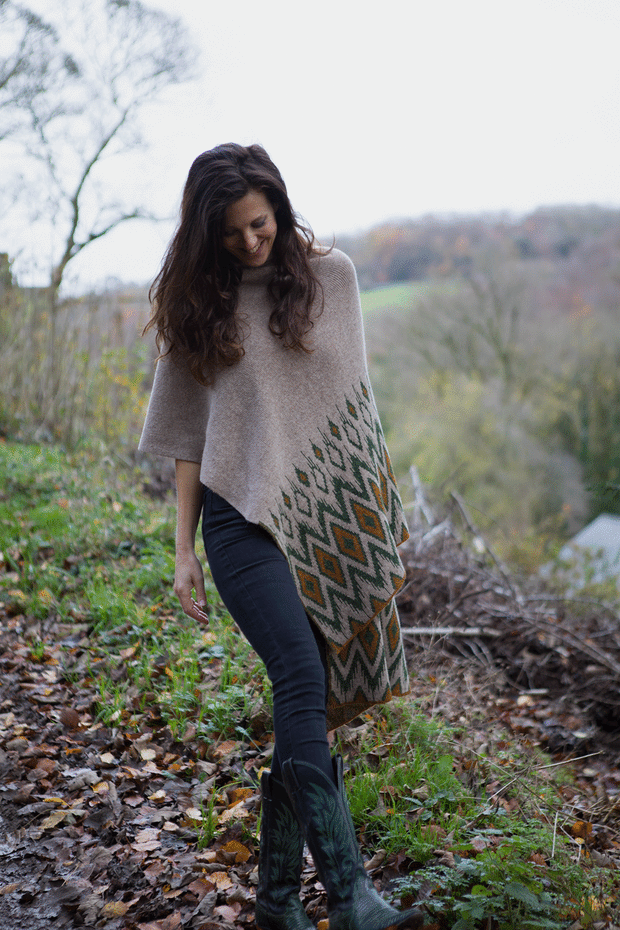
[283,756,424,930]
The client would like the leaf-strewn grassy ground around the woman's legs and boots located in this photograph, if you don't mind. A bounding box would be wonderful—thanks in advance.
[0,445,620,930]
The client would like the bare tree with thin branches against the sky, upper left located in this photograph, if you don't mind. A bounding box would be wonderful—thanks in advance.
[0,0,194,300]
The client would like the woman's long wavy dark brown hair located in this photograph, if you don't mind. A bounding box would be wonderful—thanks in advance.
[144,143,320,384]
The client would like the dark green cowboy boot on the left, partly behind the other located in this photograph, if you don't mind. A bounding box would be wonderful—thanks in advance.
[256,772,314,930]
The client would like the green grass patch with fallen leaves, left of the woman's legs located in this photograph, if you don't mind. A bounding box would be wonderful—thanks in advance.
[0,443,271,741]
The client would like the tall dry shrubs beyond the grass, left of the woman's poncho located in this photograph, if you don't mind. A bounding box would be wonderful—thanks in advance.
[0,288,152,447]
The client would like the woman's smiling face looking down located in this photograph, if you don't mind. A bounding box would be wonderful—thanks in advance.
[222,190,278,268]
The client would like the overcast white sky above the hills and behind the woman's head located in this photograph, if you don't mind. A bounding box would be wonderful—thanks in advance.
[10,0,620,290]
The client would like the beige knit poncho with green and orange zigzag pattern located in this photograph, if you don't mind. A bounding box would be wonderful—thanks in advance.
[140,249,409,728]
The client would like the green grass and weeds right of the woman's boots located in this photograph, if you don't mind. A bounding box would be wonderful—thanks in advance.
[348,702,618,930]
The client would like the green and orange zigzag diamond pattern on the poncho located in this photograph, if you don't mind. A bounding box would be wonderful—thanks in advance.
[265,381,409,726]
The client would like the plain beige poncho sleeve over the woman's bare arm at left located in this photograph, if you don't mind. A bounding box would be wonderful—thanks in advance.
[139,355,210,462]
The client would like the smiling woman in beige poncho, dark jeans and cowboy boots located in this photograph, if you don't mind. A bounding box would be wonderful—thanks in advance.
[140,144,421,930]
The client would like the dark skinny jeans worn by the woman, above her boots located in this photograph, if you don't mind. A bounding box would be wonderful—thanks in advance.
[202,488,334,780]
